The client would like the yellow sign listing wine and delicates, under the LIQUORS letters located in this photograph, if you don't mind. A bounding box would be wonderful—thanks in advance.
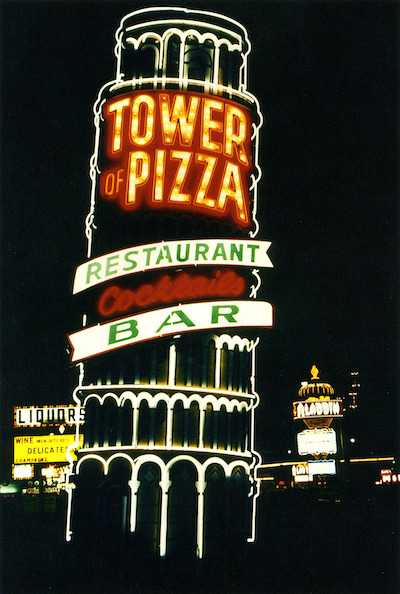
[14,435,83,464]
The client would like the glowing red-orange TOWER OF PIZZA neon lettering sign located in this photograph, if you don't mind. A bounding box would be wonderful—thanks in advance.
[99,91,253,228]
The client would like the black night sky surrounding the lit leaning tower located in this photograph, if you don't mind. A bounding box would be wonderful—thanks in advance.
[2,0,399,472]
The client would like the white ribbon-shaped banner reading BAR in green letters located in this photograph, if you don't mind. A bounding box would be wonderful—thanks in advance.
[68,300,273,362]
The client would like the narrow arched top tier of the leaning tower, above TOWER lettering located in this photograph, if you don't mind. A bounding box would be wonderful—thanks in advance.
[110,7,254,98]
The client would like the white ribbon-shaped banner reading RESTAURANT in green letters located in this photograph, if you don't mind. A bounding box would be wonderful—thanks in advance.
[73,239,273,294]
